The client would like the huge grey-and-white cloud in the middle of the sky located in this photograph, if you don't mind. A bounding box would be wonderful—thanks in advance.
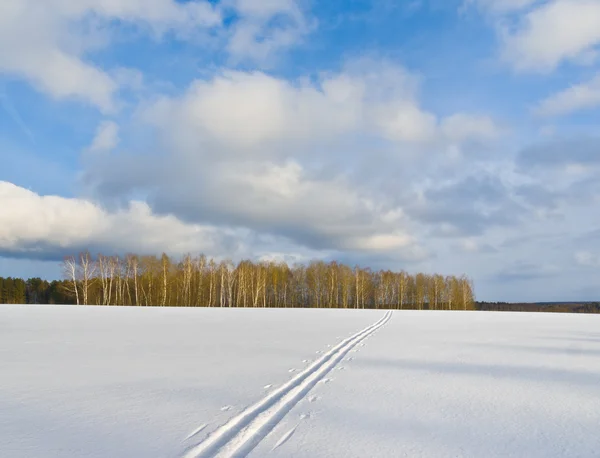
[77,61,504,258]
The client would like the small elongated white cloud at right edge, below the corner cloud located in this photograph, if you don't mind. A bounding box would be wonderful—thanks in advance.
[535,74,600,116]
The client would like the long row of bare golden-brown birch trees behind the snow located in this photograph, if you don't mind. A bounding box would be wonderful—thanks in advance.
[62,252,474,310]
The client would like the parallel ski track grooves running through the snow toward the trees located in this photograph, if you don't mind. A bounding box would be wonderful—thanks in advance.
[182,311,392,458]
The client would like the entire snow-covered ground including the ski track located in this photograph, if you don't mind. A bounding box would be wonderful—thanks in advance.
[0,306,600,458]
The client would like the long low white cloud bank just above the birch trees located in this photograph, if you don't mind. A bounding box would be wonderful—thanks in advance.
[0,178,427,262]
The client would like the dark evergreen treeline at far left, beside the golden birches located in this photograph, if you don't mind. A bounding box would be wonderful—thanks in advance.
[0,277,75,304]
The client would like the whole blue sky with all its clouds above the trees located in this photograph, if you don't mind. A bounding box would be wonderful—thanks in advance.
[0,0,600,301]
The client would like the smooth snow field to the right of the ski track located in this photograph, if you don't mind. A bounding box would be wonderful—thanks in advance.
[258,311,600,458]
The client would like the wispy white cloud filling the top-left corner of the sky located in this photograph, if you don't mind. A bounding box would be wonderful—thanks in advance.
[0,0,220,112]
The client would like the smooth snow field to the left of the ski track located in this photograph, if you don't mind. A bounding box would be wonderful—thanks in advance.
[0,306,382,458]
